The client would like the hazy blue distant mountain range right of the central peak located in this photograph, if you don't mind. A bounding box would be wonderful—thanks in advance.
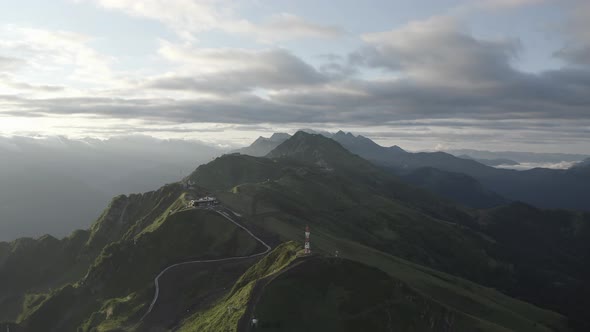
[236,131,590,211]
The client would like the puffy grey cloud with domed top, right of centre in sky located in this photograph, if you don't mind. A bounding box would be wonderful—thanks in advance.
[357,16,519,86]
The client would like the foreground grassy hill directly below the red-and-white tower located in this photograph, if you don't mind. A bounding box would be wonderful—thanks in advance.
[179,241,567,332]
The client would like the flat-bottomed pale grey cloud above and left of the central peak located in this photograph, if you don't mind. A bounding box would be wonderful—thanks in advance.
[149,42,327,93]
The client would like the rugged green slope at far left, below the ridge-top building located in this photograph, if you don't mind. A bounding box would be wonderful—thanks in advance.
[0,184,191,320]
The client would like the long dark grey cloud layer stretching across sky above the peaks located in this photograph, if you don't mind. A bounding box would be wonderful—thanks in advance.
[0,9,590,152]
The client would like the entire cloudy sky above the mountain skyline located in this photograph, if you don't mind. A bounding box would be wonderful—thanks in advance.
[0,0,590,153]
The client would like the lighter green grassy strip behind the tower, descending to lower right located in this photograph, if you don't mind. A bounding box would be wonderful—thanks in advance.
[247,218,568,331]
